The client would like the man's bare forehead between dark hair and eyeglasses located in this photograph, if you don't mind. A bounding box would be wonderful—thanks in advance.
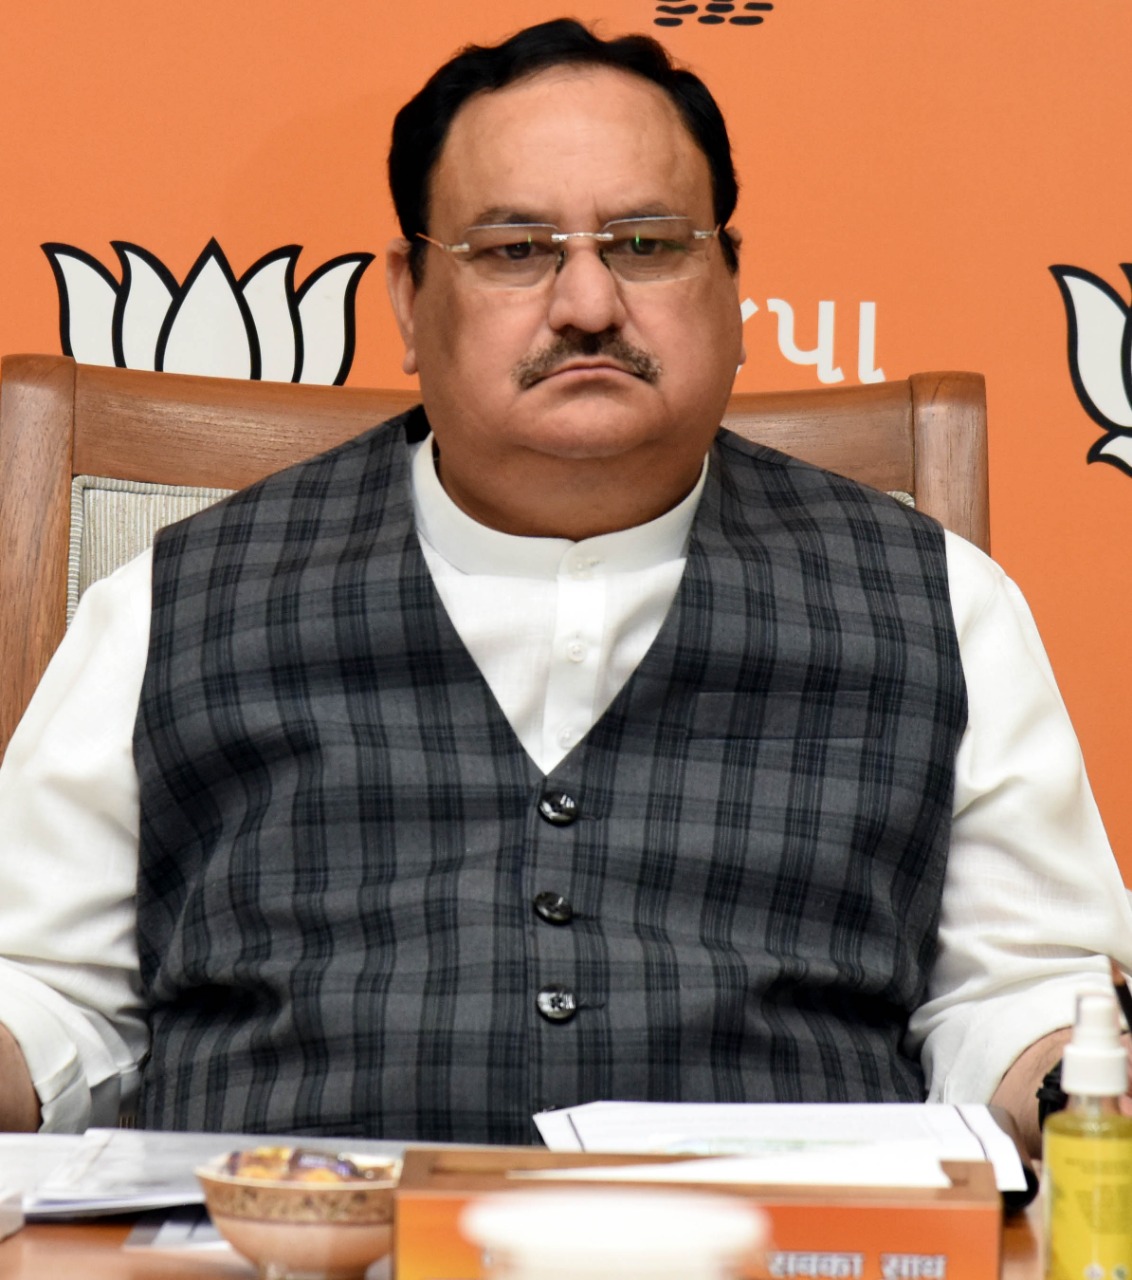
[430,67,712,232]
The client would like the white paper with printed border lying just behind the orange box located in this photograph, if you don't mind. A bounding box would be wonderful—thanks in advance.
[534,1102,1026,1190]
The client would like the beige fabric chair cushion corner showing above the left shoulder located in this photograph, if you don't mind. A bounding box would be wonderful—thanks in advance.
[67,476,232,626]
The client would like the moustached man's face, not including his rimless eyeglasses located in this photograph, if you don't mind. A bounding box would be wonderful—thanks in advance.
[389,67,741,515]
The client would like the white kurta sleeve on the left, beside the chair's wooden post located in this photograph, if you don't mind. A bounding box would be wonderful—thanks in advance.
[0,553,150,1130]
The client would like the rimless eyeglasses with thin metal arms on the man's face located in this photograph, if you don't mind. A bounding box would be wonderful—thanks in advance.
[417,218,720,288]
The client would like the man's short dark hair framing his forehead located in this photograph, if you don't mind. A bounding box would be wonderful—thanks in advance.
[389,18,739,279]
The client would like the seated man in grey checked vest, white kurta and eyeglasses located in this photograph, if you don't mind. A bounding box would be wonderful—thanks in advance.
[0,22,1132,1142]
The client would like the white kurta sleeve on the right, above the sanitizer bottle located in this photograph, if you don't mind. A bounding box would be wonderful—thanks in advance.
[909,534,1132,1102]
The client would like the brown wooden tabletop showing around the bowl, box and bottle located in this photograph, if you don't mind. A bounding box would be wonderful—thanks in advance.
[0,1204,1041,1280]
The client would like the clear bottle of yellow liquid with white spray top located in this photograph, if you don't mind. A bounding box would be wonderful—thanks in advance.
[1042,993,1132,1280]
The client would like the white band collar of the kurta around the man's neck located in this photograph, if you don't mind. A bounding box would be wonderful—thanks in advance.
[412,435,707,579]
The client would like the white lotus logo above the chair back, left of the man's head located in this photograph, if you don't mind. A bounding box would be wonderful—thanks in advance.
[42,239,374,384]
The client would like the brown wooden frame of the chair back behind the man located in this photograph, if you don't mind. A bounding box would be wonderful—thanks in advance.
[0,356,989,751]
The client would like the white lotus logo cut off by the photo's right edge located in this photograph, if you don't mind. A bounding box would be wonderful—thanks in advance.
[1050,262,1132,475]
